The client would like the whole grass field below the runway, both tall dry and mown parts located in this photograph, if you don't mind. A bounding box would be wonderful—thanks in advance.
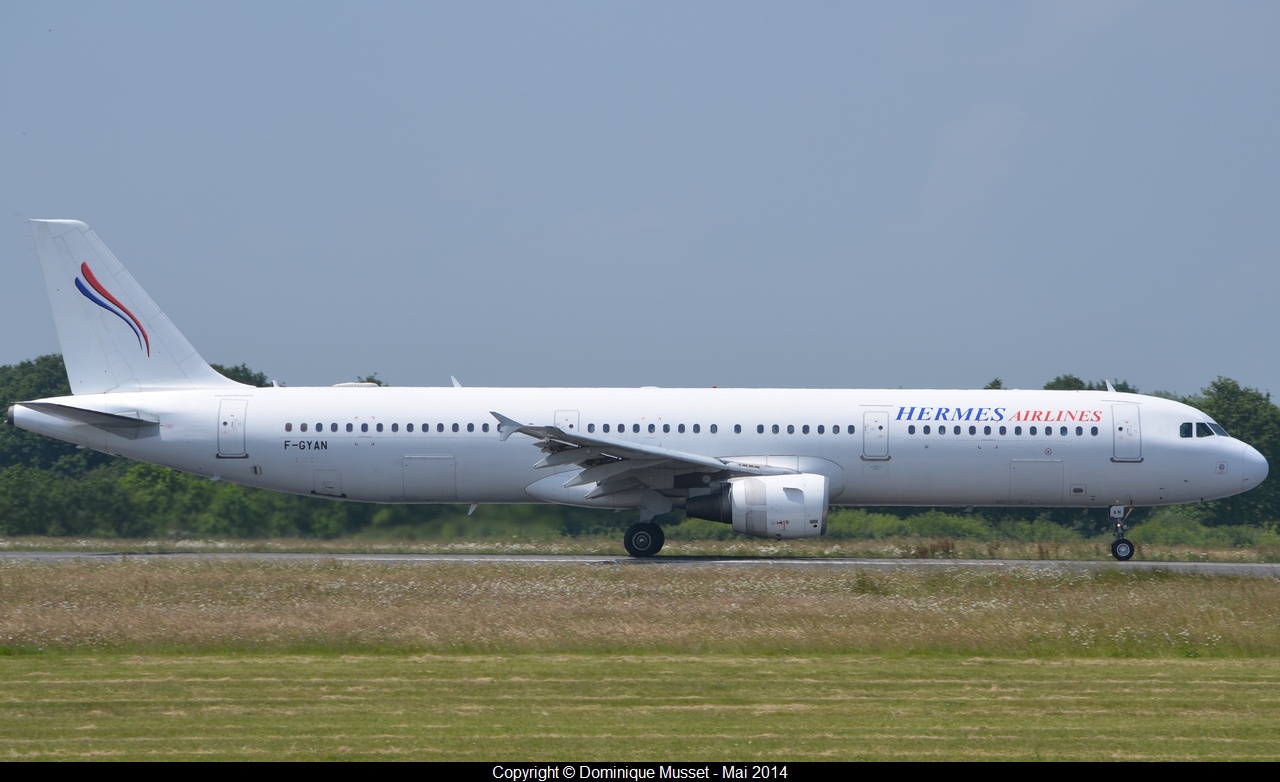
[0,558,1280,763]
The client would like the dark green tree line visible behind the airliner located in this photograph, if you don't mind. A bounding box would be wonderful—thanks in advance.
[0,356,1280,538]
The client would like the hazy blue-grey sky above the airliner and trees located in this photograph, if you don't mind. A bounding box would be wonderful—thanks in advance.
[0,0,1280,393]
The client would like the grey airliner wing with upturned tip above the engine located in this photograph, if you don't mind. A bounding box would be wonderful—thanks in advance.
[490,411,795,499]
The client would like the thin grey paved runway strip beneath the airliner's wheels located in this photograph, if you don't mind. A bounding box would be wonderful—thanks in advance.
[0,550,1280,579]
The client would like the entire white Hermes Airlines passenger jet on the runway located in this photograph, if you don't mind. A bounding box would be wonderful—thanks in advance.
[6,220,1268,561]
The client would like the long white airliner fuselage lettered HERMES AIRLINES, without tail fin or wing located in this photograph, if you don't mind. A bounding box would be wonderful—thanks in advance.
[14,387,1267,508]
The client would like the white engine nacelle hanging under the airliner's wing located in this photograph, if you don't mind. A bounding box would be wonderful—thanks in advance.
[685,472,828,540]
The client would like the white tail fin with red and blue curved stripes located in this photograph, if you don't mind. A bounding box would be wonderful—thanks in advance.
[31,220,243,394]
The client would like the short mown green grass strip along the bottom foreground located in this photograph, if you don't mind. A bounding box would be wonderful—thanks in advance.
[0,654,1280,763]
